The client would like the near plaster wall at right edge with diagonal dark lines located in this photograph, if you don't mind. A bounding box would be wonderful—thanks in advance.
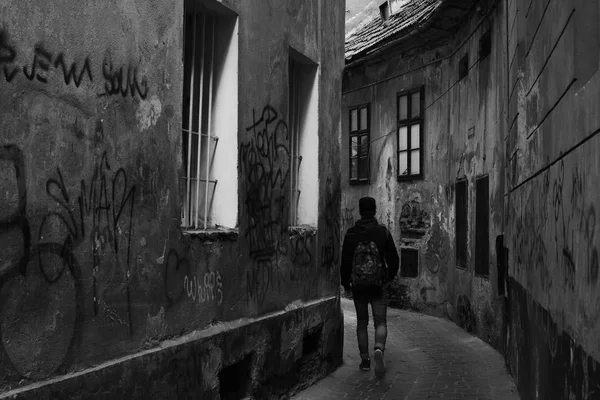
[506,1,600,399]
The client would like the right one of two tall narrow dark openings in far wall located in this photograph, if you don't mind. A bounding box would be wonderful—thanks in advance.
[475,175,490,276]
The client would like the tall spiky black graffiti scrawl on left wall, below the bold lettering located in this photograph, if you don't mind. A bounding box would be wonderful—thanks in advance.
[38,152,136,324]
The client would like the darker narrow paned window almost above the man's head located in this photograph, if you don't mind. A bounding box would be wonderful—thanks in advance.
[349,104,371,183]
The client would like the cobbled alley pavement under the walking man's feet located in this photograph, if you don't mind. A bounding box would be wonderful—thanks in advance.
[291,298,519,400]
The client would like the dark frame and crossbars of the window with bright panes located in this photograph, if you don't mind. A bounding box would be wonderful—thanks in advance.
[396,85,425,181]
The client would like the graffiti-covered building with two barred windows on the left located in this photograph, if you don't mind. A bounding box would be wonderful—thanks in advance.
[0,0,344,399]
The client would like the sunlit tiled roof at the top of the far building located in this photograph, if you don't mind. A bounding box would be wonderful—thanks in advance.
[345,0,443,61]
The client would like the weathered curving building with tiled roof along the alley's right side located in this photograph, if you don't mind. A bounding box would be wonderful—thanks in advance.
[342,0,600,398]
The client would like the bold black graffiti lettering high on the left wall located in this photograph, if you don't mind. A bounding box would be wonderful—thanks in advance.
[0,30,148,99]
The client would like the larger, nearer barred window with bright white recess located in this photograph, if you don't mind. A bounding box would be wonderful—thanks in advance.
[182,0,238,229]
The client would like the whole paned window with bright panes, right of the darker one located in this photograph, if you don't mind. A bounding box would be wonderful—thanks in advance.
[397,87,423,180]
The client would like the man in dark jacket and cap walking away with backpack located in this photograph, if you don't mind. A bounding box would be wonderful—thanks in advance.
[340,197,399,378]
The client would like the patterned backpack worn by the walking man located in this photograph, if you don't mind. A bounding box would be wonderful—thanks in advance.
[352,240,387,288]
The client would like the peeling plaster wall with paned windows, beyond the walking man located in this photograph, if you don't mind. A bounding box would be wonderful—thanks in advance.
[342,2,506,346]
